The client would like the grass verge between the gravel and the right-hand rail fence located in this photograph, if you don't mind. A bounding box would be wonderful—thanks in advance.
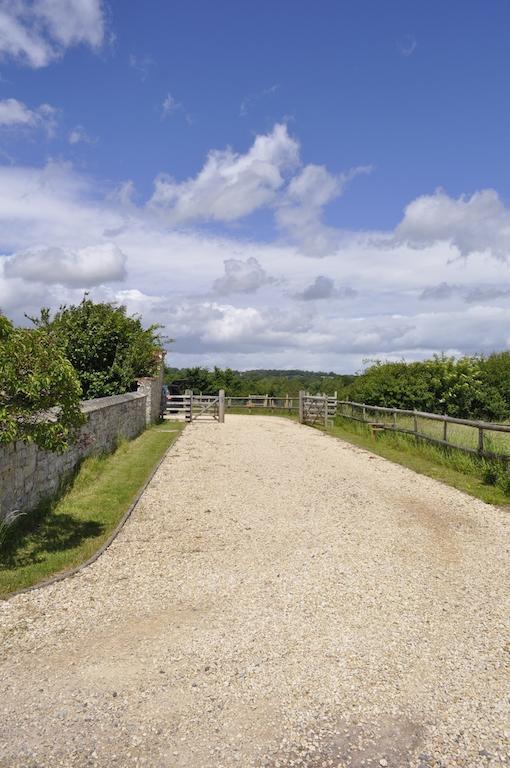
[328,417,510,506]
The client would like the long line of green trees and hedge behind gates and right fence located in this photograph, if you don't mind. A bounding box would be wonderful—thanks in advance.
[165,352,510,421]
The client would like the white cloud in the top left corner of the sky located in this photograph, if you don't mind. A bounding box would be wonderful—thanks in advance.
[0,0,105,67]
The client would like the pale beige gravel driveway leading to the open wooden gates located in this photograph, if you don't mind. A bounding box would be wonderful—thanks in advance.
[0,415,510,768]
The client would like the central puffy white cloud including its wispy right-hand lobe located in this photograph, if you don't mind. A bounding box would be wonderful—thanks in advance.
[150,121,372,257]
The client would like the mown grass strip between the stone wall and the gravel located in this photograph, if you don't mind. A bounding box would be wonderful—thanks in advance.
[0,421,184,598]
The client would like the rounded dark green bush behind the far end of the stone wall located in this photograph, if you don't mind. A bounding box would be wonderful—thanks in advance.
[31,295,162,399]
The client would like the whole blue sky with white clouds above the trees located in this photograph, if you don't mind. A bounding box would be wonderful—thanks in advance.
[0,0,510,371]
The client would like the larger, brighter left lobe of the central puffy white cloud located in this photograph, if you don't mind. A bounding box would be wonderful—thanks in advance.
[151,125,299,224]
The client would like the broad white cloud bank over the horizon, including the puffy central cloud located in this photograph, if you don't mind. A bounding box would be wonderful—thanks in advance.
[0,129,510,371]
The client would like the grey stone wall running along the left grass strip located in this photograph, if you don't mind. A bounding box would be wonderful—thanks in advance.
[0,392,147,518]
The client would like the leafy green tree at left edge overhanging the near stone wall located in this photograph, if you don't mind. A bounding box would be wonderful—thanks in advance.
[0,315,84,451]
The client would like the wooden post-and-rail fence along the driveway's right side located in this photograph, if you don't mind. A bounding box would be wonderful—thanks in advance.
[337,400,510,462]
